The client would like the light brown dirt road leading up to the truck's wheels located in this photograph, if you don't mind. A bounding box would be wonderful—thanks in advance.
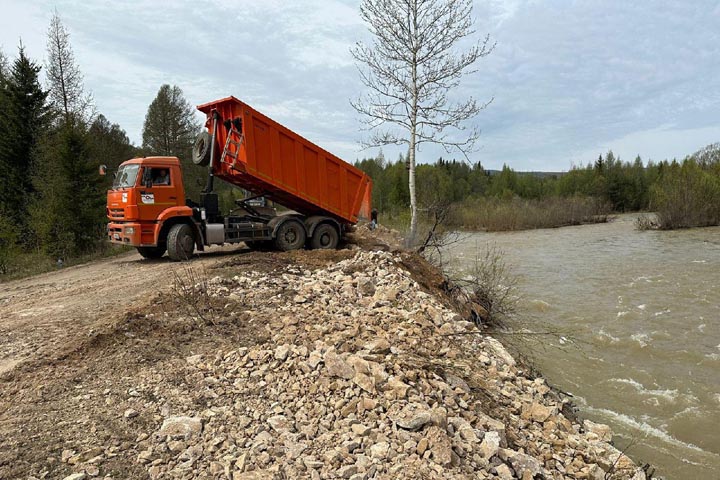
[0,246,248,375]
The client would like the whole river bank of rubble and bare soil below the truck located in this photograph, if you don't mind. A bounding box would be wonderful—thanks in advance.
[0,232,645,480]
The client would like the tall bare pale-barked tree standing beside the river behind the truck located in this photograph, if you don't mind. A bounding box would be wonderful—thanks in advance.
[351,0,495,242]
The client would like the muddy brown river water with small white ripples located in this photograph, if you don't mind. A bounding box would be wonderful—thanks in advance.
[450,215,720,480]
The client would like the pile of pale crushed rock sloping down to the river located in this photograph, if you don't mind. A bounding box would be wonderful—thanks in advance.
[63,251,645,480]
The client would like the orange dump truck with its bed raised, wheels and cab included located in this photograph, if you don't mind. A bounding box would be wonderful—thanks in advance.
[107,97,372,260]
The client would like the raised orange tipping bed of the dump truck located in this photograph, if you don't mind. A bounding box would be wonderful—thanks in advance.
[197,97,372,224]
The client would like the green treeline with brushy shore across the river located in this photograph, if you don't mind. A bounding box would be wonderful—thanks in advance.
[355,144,720,231]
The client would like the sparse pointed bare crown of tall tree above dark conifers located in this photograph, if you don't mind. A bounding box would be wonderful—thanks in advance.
[45,12,95,123]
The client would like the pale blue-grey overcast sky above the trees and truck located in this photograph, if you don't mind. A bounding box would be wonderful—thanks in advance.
[0,0,720,171]
